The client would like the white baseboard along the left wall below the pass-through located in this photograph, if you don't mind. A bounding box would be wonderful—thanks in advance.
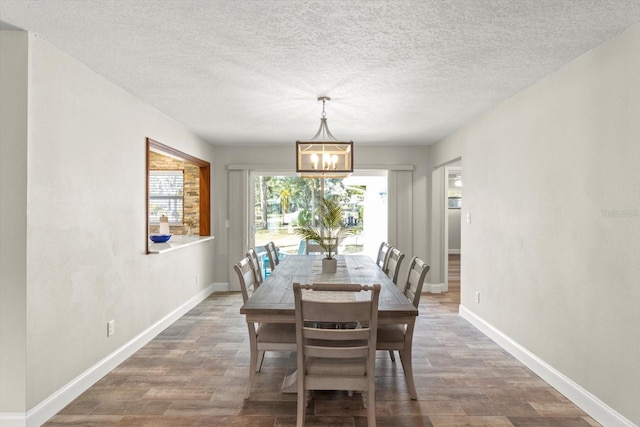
[0,283,218,427]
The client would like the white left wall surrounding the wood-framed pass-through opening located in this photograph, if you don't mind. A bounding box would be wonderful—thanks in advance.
[1,31,215,420]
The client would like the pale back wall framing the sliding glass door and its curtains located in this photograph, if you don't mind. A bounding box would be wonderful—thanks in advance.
[212,145,431,288]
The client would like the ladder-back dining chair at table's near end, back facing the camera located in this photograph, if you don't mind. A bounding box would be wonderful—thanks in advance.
[293,283,380,427]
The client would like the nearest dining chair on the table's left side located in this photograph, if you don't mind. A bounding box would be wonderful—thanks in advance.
[233,256,296,399]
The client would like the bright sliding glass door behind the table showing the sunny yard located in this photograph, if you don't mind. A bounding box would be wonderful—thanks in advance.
[249,171,388,259]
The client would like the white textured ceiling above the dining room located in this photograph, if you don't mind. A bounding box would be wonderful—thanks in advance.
[0,0,640,145]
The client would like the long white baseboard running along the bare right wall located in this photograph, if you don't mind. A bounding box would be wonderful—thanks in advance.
[459,304,637,427]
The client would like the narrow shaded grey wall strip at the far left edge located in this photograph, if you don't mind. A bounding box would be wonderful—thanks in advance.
[0,31,28,414]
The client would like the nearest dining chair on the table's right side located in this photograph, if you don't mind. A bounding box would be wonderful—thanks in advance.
[376,257,431,400]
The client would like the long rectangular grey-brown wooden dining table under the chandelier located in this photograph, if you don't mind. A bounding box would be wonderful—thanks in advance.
[240,254,418,400]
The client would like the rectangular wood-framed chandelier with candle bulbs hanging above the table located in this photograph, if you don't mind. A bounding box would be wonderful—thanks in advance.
[296,96,353,178]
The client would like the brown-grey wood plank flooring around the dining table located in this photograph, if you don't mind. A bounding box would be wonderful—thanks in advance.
[45,270,599,427]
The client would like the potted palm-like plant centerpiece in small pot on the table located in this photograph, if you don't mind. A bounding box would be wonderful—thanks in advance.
[296,197,342,273]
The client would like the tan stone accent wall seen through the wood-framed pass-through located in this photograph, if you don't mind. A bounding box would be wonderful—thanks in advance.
[149,151,200,235]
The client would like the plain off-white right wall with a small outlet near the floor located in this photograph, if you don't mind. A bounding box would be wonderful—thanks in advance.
[432,24,640,425]
